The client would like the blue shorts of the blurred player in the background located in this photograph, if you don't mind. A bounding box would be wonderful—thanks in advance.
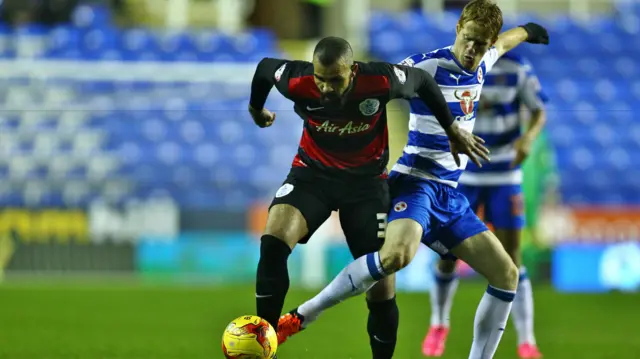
[458,184,525,229]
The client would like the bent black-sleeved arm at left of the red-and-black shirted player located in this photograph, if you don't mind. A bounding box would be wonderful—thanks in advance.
[249,57,287,127]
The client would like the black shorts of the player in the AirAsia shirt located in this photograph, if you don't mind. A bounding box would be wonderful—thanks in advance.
[269,167,391,258]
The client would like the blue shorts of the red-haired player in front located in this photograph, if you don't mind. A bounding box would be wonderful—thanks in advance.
[388,172,488,259]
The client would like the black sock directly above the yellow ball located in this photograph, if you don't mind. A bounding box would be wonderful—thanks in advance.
[256,235,291,330]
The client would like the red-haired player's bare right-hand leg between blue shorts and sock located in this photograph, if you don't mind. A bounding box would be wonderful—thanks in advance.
[451,231,518,290]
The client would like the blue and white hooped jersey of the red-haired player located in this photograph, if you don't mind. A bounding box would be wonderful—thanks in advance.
[392,47,499,187]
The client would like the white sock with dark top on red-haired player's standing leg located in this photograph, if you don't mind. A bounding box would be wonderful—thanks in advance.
[469,286,516,359]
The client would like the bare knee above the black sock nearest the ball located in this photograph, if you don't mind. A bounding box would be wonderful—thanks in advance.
[264,204,308,248]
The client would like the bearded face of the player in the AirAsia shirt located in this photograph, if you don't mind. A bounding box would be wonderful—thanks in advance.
[313,61,356,107]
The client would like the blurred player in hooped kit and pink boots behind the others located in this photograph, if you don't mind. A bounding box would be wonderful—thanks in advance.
[422,53,547,359]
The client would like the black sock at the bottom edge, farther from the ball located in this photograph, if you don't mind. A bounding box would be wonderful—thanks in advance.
[367,297,400,359]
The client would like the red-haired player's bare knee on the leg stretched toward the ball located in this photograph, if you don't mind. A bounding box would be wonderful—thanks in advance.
[380,219,422,273]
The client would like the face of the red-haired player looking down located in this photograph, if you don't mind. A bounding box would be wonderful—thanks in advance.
[453,21,496,71]
